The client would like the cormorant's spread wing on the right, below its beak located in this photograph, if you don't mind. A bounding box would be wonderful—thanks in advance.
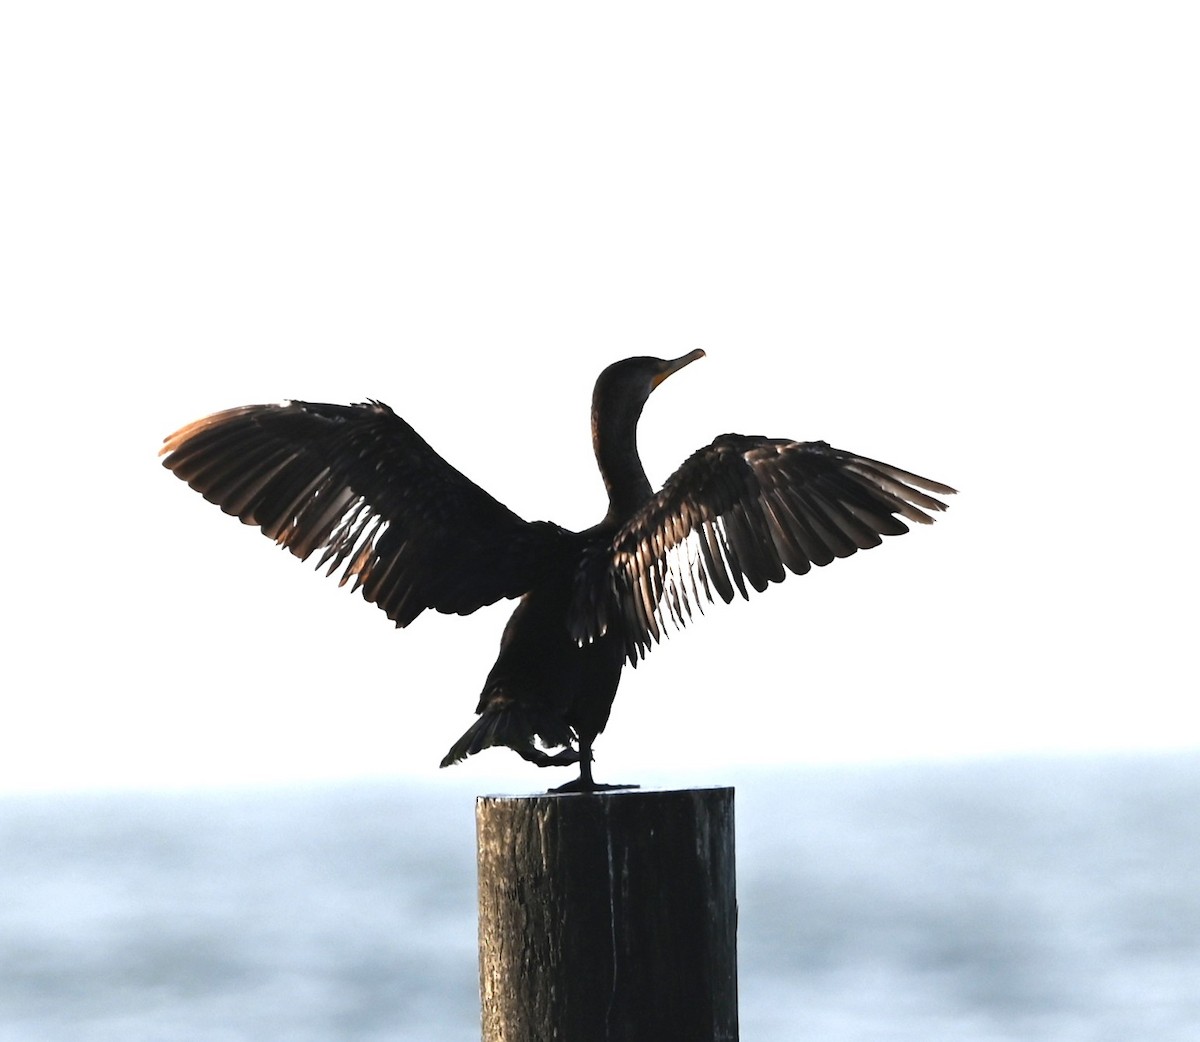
[572,435,954,663]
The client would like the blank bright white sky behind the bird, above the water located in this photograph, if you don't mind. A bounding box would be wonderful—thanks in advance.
[0,0,1200,790]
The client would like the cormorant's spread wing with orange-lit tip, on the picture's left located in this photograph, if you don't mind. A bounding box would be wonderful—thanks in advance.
[162,401,568,627]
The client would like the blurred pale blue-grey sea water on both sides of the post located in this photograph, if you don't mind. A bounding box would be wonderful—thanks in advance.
[0,755,1200,1042]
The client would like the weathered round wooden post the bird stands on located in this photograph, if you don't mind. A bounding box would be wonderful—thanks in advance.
[475,789,738,1042]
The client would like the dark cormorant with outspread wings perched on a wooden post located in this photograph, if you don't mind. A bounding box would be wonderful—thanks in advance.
[162,351,954,791]
